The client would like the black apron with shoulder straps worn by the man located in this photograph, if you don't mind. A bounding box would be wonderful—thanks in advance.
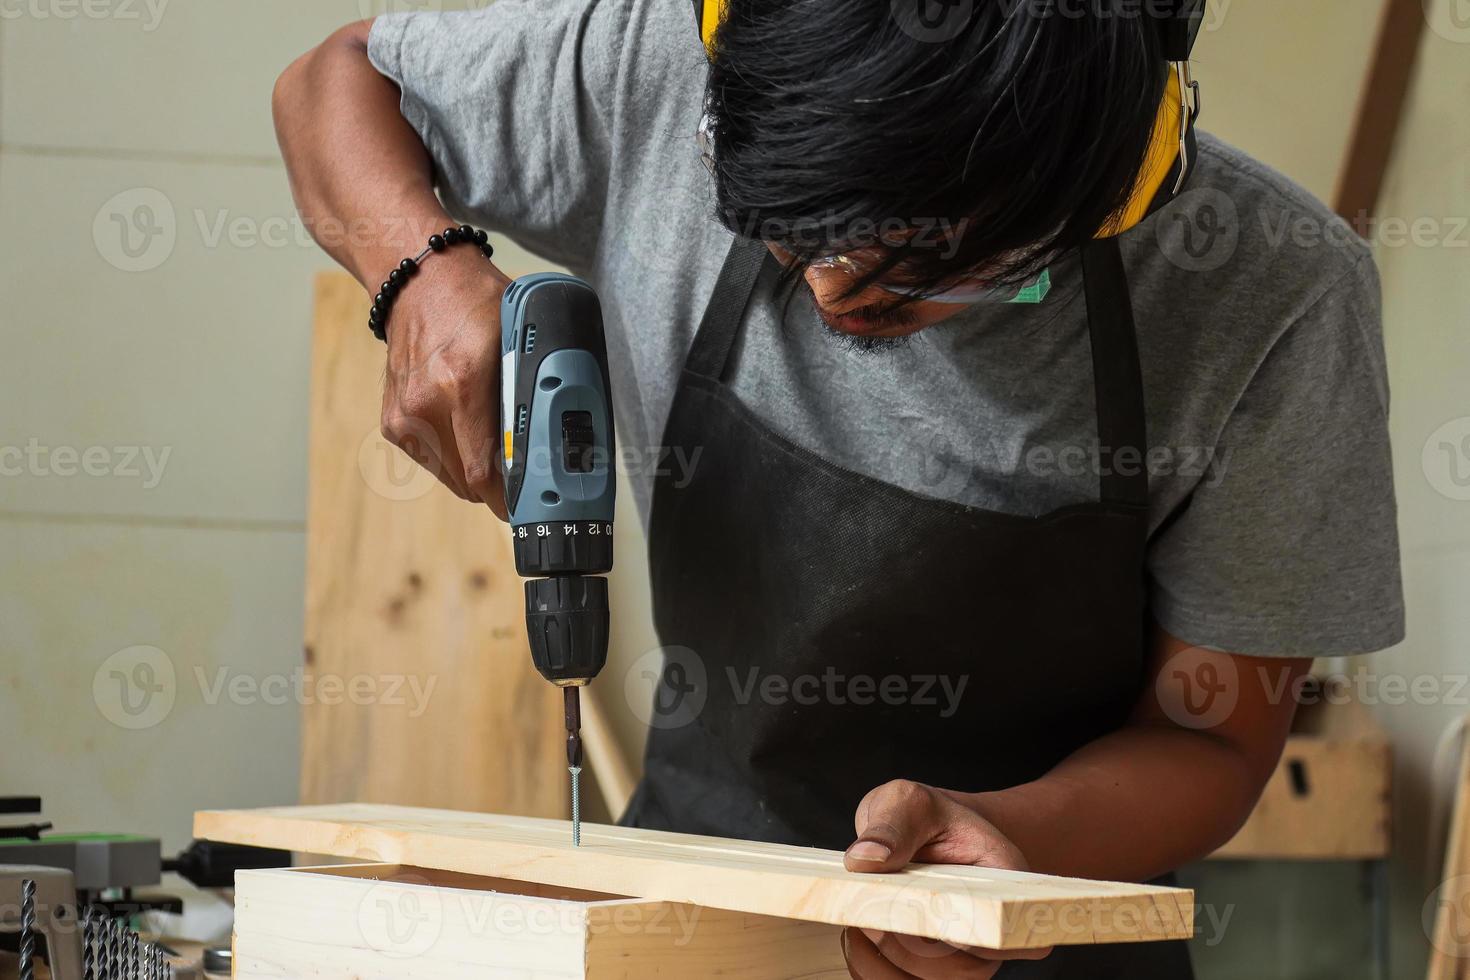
[623,233,1192,980]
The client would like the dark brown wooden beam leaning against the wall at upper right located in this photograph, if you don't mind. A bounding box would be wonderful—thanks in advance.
[1335,0,1426,224]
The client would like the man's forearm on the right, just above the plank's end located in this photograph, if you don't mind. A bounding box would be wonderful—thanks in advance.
[972,726,1269,882]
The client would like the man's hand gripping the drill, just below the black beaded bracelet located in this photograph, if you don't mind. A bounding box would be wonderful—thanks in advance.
[382,245,510,520]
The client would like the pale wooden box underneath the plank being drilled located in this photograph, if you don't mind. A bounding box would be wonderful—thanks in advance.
[235,865,848,980]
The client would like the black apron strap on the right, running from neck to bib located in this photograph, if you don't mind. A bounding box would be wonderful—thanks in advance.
[1082,238,1148,507]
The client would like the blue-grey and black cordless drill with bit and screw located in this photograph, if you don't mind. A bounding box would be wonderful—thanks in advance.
[500,273,617,846]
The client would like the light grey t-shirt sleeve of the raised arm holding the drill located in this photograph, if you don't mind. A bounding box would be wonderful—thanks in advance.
[368,0,628,267]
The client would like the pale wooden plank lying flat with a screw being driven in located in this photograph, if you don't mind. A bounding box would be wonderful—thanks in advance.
[194,804,1194,949]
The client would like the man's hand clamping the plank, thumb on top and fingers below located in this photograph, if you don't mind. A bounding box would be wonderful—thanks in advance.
[842,780,1051,980]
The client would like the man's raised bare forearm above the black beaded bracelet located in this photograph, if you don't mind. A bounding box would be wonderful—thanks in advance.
[272,21,448,292]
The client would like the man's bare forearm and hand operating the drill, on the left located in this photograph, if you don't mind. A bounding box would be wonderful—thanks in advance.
[272,21,510,520]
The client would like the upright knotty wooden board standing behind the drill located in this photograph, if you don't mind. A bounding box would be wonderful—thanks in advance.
[301,273,567,815]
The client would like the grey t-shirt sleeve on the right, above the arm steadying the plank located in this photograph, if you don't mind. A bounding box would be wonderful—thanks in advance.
[1150,257,1404,657]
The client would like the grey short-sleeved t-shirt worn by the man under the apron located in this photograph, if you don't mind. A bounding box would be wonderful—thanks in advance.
[369,0,1404,657]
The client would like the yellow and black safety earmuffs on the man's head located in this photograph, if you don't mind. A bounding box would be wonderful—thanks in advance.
[694,0,1208,238]
